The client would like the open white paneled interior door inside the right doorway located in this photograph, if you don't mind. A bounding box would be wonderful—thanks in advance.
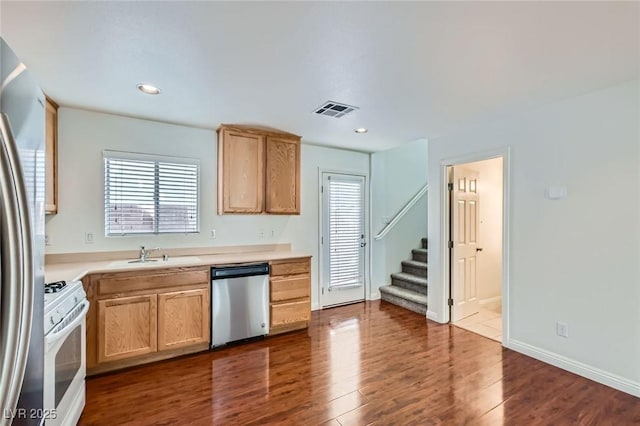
[451,166,480,322]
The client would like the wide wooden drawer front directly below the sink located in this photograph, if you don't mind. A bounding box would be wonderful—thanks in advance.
[98,269,209,295]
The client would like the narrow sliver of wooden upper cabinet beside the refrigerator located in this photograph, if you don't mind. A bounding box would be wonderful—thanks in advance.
[45,98,58,214]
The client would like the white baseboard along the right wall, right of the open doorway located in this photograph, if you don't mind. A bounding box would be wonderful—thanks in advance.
[508,339,640,398]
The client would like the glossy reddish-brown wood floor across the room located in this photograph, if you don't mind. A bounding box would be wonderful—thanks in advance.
[80,301,640,426]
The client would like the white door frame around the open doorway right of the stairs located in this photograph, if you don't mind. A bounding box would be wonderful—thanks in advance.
[439,146,511,347]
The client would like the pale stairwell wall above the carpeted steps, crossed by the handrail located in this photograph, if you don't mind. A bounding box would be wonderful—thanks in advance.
[371,139,428,296]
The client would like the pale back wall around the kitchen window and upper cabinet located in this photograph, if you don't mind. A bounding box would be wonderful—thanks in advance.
[47,107,369,308]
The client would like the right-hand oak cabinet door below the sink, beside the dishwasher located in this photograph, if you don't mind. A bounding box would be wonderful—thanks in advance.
[158,288,210,351]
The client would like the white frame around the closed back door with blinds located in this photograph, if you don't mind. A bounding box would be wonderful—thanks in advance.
[313,167,371,309]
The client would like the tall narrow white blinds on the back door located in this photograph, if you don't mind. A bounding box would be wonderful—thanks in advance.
[325,175,364,288]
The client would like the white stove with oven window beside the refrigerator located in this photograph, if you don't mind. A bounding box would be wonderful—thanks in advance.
[44,281,89,426]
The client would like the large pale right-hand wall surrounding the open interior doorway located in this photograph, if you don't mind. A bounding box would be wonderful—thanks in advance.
[429,80,640,395]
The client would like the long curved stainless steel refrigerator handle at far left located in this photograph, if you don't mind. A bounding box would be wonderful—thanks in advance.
[0,114,34,425]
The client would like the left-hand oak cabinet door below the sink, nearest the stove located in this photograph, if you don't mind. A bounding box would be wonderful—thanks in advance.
[98,294,158,362]
